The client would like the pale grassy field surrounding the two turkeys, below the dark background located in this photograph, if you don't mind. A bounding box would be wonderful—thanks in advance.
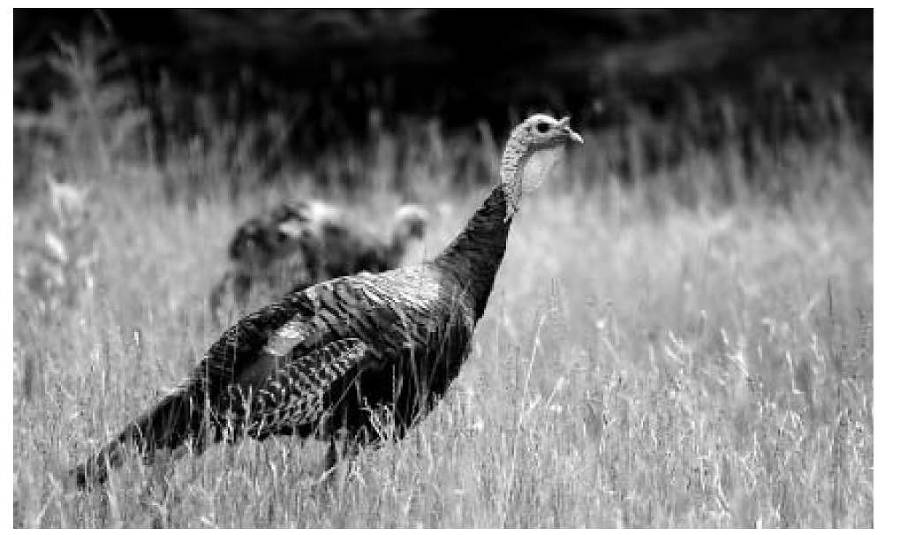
[12,121,873,527]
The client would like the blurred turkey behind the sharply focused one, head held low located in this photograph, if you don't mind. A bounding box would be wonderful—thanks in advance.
[209,201,428,317]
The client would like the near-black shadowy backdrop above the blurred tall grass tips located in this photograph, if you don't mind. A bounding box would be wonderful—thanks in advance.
[14,9,872,122]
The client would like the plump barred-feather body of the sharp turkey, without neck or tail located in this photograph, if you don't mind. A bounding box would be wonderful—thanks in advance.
[214,264,476,440]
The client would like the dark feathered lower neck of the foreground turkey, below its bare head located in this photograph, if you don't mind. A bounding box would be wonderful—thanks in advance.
[434,184,512,318]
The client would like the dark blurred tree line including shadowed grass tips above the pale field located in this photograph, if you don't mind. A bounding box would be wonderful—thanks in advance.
[14,9,873,200]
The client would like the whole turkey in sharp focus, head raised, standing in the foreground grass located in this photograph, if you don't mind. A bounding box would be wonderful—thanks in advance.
[73,115,582,488]
